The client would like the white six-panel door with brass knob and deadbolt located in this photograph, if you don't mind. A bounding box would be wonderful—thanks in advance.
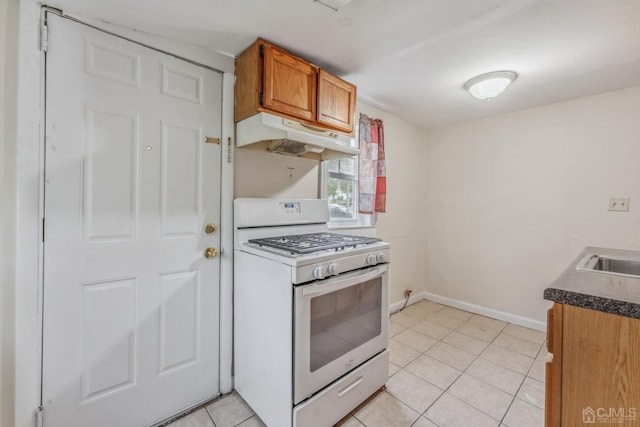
[42,14,222,427]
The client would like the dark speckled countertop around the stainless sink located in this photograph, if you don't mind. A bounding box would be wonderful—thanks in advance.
[544,247,640,319]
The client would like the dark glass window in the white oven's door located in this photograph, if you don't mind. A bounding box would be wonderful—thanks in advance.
[310,277,382,372]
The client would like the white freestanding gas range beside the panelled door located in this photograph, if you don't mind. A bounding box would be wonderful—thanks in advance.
[234,198,390,427]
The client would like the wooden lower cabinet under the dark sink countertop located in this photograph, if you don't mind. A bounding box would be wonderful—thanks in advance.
[545,304,640,427]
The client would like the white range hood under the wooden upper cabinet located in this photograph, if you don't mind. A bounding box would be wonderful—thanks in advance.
[236,113,360,160]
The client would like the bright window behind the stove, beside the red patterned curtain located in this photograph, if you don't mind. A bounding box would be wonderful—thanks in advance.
[322,156,372,227]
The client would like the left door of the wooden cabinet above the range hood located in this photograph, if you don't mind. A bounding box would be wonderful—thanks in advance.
[262,44,317,120]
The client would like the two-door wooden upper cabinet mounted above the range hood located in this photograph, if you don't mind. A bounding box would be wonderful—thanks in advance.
[235,39,356,134]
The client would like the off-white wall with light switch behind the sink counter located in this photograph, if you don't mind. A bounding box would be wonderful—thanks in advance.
[421,87,640,321]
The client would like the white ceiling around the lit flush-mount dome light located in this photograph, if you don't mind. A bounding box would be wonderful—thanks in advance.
[48,0,640,128]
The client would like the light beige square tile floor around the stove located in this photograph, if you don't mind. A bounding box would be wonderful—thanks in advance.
[170,301,546,427]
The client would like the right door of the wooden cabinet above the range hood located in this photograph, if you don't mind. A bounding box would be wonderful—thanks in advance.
[318,70,356,133]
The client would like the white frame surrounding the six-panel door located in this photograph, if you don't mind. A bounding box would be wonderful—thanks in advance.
[11,6,235,427]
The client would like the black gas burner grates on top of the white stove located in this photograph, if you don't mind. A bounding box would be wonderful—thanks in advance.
[249,233,381,254]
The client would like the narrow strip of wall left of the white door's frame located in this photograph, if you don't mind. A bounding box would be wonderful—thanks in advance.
[0,0,18,426]
